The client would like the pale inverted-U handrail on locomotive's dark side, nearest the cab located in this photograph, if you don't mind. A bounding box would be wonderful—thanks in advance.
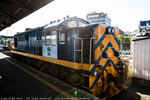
[74,38,83,63]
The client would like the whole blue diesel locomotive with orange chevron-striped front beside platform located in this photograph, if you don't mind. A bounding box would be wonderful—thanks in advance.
[11,17,123,97]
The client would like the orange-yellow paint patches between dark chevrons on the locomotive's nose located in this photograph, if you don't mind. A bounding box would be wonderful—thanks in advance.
[89,25,120,96]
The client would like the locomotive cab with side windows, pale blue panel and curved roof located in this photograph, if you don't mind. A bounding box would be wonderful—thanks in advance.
[42,17,88,61]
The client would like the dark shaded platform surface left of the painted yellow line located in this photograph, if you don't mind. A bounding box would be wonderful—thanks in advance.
[0,55,59,99]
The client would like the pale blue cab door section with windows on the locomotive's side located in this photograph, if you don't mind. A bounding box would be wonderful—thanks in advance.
[43,30,57,59]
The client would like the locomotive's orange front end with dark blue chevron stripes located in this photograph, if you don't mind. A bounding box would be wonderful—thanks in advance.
[89,25,121,95]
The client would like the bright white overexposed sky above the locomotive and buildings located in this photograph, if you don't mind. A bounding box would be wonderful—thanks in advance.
[0,0,150,36]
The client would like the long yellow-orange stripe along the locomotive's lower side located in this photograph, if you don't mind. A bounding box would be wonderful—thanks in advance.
[11,50,91,71]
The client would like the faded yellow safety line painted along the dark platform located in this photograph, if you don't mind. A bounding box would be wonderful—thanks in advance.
[5,58,77,100]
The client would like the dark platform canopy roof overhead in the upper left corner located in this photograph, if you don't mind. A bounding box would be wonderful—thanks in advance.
[0,0,54,31]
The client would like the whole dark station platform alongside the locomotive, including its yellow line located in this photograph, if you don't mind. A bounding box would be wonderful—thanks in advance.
[0,49,99,100]
